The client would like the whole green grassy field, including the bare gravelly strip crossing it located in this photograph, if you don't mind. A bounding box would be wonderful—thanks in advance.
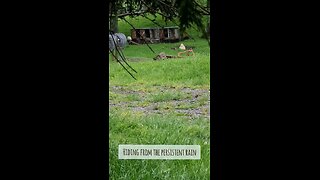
[109,15,210,180]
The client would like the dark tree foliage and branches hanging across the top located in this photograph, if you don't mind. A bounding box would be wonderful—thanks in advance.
[109,0,210,38]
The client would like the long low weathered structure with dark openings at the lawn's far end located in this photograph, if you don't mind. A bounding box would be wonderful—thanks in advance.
[131,26,182,43]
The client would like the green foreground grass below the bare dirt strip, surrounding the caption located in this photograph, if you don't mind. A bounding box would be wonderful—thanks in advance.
[109,110,210,180]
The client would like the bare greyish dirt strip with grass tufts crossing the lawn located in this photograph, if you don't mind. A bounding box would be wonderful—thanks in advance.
[109,86,210,119]
